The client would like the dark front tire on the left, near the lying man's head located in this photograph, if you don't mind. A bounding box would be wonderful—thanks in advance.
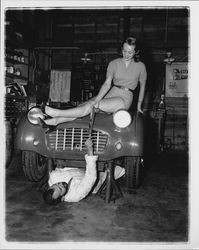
[22,151,47,182]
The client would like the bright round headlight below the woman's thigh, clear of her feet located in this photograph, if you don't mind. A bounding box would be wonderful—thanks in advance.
[113,110,131,128]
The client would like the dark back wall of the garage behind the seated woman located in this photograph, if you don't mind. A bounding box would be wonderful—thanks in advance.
[5,7,189,150]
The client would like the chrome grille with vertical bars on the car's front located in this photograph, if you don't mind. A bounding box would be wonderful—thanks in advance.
[46,128,108,153]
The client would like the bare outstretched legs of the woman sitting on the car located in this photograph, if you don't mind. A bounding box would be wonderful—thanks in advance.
[45,97,125,125]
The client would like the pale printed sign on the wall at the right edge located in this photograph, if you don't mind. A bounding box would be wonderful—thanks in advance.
[165,63,188,97]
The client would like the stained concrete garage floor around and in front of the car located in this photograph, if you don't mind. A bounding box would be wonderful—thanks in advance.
[5,152,189,243]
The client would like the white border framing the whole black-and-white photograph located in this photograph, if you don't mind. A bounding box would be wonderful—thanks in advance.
[0,0,199,250]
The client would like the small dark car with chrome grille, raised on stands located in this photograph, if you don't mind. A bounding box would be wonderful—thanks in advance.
[15,106,144,192]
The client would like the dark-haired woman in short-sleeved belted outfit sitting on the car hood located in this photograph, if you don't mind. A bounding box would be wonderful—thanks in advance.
[42,37,147,126]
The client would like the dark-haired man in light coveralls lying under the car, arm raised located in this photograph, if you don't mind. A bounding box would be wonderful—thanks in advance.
[43,138,125,205]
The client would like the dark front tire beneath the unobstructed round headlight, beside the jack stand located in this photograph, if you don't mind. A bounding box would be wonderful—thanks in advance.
[125,156,141,193]
